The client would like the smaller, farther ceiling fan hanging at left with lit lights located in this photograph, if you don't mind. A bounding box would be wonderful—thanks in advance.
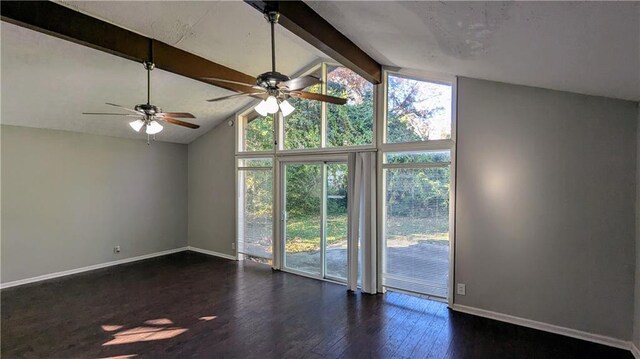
[82,57,200,143]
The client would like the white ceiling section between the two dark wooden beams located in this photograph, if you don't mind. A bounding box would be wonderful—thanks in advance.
[61,0,326,76]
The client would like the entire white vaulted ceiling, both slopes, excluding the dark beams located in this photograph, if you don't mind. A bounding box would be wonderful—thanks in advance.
[1,1,640,143]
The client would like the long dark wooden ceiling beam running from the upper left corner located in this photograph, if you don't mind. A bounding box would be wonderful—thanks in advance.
[0,1,256,92]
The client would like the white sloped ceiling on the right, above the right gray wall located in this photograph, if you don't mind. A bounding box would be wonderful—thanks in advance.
[307,1,640,101]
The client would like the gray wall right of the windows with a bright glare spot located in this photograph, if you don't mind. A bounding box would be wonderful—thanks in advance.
[455,78,638,340]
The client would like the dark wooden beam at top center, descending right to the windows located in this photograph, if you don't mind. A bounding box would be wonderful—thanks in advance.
[245,0,382,84]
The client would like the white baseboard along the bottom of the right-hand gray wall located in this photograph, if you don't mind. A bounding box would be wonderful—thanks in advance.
[451,304,632,350]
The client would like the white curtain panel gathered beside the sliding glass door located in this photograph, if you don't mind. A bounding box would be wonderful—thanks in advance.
[347,152,377,294]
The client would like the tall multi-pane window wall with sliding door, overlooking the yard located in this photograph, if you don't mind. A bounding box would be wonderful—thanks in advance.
[237,64,455,298]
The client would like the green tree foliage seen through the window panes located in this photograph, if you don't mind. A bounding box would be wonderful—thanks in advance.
[245,66,451,224]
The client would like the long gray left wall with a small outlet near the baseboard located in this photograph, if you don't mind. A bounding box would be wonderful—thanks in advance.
[1,125,187,283]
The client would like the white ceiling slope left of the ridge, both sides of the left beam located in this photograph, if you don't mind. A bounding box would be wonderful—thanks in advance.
[1,2,325,143]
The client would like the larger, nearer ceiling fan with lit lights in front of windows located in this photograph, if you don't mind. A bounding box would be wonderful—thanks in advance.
[203,11,347,116]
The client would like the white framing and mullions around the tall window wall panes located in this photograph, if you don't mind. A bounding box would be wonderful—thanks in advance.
[234,63,458,307]
